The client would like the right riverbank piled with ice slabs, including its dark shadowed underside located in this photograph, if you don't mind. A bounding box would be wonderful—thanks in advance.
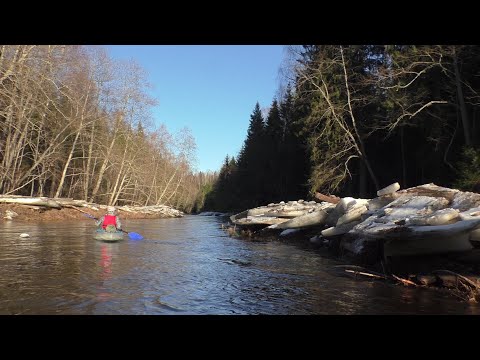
[224,183,480,302]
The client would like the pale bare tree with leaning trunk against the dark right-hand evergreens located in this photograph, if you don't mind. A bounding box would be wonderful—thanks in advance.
[296,46,379,190]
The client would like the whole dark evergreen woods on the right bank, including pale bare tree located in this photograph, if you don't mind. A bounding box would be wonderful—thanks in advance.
[205,45,480,211]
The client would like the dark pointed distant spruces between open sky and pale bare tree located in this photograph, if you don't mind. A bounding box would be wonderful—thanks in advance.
[204,87,308,211]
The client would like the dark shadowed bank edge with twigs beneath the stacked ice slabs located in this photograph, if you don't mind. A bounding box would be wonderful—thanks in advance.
[222,222,480,304]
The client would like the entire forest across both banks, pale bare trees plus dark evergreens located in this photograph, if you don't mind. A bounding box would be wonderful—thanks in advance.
[0,45,480,213]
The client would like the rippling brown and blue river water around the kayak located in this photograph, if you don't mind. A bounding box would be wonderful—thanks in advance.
[0,216,480,315]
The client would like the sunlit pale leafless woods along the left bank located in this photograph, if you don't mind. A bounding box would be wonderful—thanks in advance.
[0,45,215,212]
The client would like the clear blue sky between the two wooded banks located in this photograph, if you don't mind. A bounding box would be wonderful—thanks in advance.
[106,45,284,171]
